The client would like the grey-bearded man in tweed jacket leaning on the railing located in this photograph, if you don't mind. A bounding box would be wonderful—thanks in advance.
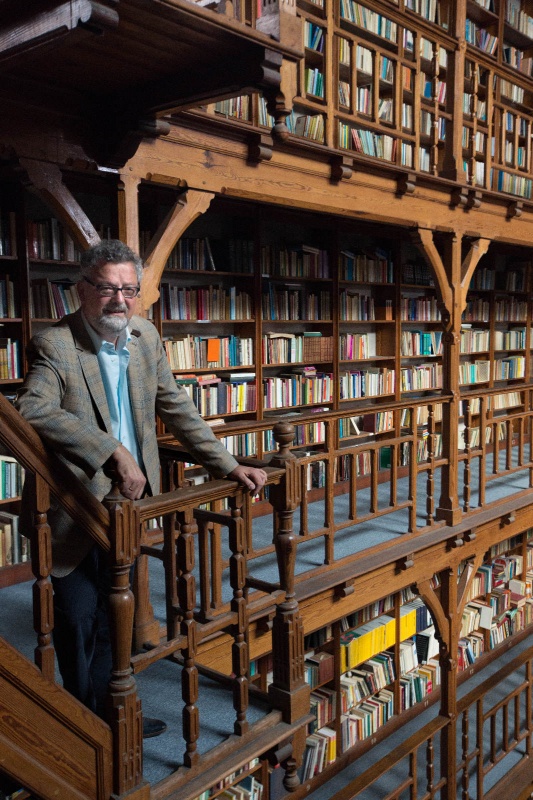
[16,240,266,736]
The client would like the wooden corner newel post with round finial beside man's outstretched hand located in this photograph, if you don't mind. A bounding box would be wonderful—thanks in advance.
[269,422,310,790]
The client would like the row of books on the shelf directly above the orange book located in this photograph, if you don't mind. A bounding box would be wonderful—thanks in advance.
[161,283,252,321]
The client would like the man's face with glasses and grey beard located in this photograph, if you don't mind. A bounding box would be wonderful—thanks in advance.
[78,262,139,342]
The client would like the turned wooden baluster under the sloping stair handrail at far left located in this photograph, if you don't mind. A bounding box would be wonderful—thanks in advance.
[31,475,55,681]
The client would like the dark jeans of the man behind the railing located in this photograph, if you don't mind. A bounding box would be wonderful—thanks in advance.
[52,545,112,717]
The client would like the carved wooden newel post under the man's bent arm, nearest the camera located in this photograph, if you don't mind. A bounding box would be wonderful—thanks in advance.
[104,485,150,800]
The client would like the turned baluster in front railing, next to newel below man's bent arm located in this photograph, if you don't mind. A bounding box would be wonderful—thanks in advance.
[176,508,200,767]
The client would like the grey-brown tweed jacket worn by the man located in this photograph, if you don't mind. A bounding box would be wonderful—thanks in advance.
[16,311,237,576]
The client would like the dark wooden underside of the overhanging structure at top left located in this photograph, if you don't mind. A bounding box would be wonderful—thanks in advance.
[0,0,301,166]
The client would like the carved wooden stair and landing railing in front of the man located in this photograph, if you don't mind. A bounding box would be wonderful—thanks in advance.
[0,396,309,800]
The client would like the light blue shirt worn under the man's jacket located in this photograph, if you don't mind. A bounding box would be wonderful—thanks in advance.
[82,314,142,468]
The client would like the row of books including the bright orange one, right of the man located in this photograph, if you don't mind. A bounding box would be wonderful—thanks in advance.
[163,335,255,370]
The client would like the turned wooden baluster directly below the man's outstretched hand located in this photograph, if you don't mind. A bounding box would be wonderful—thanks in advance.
[228,491,250,735]
